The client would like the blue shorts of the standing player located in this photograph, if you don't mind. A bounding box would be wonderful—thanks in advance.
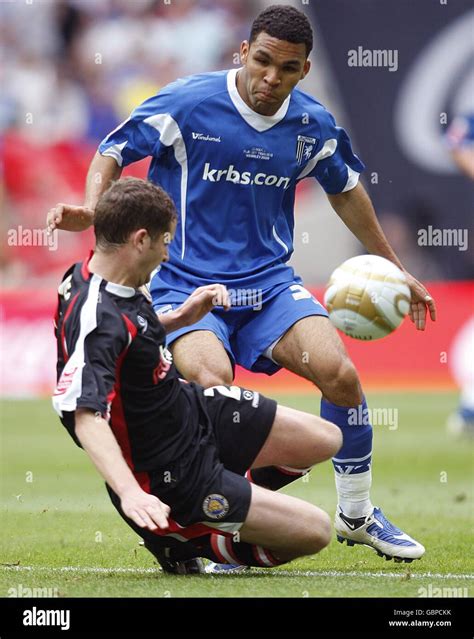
[153,278,328,375]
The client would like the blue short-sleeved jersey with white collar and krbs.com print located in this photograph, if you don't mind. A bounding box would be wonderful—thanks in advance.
[99,69,364,292]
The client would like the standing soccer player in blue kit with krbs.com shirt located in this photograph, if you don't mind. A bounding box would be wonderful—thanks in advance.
[48,5,436,570]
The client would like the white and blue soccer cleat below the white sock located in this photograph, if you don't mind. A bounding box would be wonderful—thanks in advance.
[334,506,425,563]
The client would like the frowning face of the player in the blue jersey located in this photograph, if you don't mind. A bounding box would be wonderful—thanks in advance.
[237,31,311,115]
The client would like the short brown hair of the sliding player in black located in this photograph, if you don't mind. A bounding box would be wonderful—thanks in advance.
[94,177,177,248]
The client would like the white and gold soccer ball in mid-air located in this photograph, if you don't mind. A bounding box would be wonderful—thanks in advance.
[324,255,410,340]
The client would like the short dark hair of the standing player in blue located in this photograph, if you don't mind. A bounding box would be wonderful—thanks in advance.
[249,4,313,57]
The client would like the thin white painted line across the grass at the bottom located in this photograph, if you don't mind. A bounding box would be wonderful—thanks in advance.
[0,565,474,579]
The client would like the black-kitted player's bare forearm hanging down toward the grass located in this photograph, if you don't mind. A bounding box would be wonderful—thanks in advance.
[75,409,170,530]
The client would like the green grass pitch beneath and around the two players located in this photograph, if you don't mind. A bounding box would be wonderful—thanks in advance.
[0,392,474,597]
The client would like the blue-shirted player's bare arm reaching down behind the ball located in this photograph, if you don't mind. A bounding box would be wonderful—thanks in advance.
[328,182,436,331]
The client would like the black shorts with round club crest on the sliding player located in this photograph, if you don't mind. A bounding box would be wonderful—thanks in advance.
[108,384,277,542]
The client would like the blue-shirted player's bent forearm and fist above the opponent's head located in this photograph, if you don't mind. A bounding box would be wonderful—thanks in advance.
[46,151,122,233]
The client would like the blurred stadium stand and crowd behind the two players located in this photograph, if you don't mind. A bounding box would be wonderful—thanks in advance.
[0,0,473,395]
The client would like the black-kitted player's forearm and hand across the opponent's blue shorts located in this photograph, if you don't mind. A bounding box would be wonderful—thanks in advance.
[158,284,231,333]
